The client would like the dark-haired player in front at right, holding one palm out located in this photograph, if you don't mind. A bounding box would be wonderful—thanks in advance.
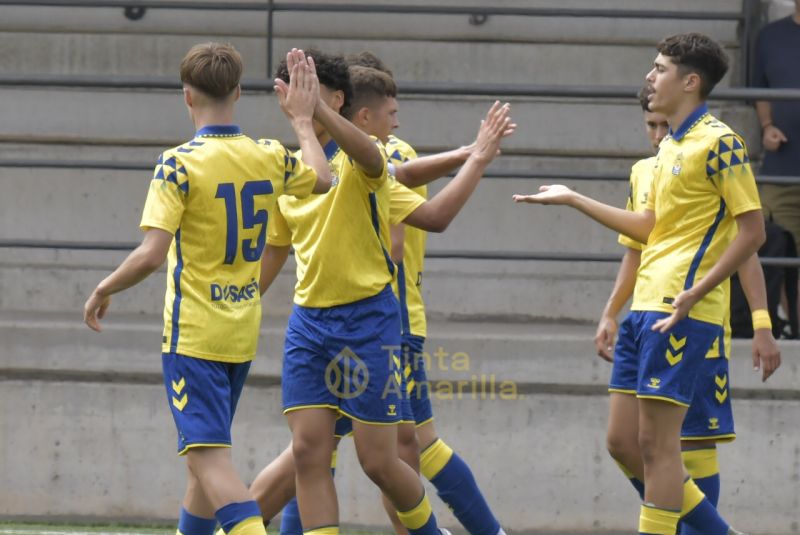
[514,33,765,535]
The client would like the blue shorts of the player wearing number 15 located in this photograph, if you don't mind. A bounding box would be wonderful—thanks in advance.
[161,353,250,455]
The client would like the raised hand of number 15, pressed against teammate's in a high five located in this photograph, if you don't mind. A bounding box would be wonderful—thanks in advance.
[274,48,319,121]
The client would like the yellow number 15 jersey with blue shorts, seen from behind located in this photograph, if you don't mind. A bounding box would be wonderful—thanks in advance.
[141,125,317,453]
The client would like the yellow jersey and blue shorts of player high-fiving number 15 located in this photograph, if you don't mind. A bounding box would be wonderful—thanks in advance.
[267,141,410,424]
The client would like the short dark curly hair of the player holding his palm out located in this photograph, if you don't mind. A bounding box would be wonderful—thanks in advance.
[656,33,729,99]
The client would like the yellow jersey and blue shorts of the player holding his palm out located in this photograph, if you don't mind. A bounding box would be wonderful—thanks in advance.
[610,104,760,406]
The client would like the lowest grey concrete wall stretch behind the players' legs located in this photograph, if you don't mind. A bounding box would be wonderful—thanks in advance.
[0,314,800,535]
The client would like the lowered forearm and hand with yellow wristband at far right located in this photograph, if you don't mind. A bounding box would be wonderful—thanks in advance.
[738,255,781,381]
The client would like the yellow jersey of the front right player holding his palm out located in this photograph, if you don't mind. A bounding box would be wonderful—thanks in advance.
[631,104,761,325]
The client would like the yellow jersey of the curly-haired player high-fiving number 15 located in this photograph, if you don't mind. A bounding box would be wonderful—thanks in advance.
[267,138,395,308]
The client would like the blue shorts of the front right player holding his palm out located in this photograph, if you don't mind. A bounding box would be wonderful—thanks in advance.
[608,311,722,407]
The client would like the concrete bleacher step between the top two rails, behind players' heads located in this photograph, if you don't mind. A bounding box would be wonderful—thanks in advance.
[0,32,740,86]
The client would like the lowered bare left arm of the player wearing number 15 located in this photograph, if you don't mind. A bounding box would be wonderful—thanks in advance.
[83,228,173,332]
